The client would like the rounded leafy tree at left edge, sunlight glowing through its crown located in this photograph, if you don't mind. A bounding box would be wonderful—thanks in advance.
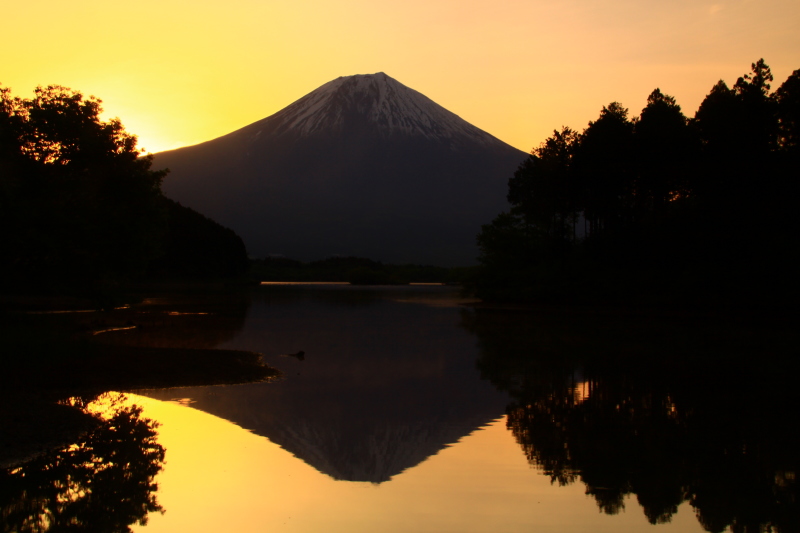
[0,85,166,279]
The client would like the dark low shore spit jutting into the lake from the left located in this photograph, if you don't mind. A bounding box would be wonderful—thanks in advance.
[0,295,281,469]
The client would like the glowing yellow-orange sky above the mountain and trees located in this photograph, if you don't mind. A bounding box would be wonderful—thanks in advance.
[0,0,800,152]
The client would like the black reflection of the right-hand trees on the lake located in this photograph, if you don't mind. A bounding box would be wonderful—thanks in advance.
[464,310,800,532]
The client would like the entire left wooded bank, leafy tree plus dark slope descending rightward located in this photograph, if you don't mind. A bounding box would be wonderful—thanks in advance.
[0,86,247,298]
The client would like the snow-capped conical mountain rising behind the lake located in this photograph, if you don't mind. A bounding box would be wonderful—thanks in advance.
[154,73,527,266]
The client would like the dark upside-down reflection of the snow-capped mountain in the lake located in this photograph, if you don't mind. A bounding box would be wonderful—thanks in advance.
[142,287,508,483]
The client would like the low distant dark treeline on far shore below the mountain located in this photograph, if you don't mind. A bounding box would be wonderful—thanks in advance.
[250,257,474,285]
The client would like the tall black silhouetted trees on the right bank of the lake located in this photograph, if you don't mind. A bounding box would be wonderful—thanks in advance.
[478,60,800,304]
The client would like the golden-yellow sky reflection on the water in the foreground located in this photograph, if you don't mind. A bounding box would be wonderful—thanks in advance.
[130,392,702,532]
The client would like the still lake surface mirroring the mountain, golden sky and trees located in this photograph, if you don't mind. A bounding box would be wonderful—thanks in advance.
[3,286,800,533]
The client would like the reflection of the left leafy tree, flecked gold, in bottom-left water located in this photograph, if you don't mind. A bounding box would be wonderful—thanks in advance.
[0,392,165,533]
